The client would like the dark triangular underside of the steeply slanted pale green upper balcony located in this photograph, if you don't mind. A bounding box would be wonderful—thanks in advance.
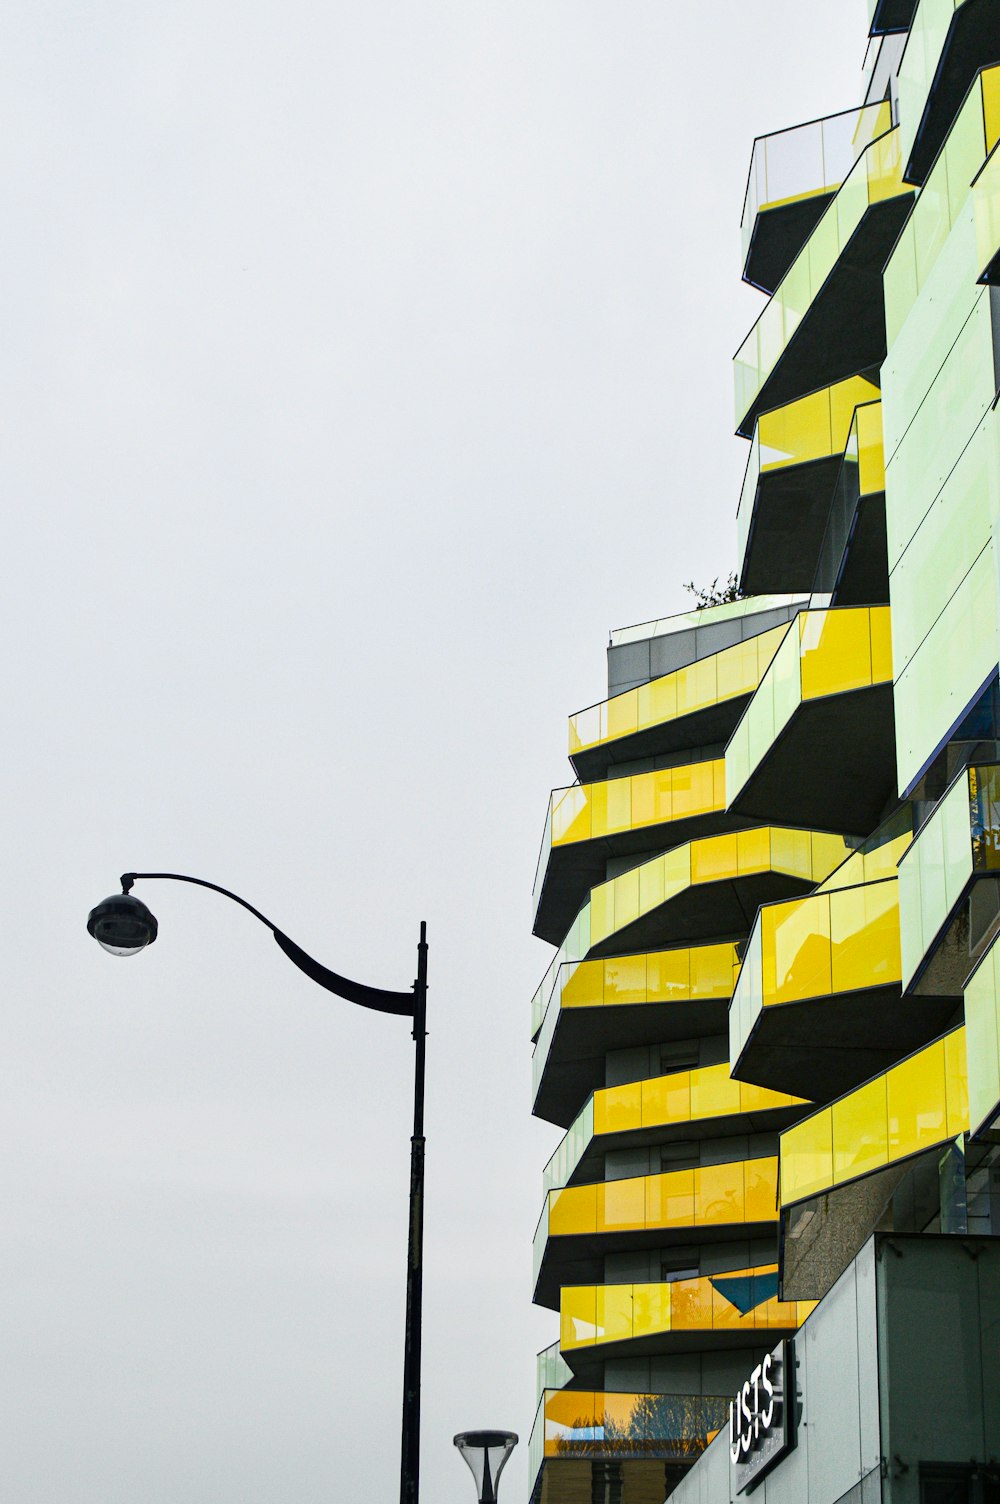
[737,196,911,439]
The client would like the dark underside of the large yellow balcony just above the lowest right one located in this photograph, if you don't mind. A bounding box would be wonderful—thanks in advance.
[732,984,955,1116]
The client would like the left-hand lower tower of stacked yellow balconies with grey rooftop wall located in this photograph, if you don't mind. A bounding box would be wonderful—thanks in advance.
[531,597,824,1499]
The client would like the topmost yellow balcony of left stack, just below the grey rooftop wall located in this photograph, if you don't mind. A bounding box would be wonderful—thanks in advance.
[570,623,788,782]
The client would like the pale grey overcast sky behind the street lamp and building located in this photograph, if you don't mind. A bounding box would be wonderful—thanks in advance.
[0,0,866,1504]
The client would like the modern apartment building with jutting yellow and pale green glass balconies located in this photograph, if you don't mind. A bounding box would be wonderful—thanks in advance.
[531,0,1000,1504]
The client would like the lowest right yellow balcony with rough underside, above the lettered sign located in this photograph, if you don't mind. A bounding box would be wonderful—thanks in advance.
[780,1027,968,1298]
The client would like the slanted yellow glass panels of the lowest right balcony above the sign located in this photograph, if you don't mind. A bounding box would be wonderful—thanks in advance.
[780,1027,968,1211]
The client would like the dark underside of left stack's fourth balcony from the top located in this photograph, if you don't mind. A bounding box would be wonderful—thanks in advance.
[532,997,724,1131]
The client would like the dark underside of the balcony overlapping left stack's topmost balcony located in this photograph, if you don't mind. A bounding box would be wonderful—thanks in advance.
[721,683,896,836]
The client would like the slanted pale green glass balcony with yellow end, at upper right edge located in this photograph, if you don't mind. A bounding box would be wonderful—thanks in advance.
[884,63,1000,346]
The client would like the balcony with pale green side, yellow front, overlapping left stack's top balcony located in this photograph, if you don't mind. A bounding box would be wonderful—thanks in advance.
[726,606,896,836]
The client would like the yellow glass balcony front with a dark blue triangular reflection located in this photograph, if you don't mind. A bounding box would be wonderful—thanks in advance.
[559,1263,815,1366]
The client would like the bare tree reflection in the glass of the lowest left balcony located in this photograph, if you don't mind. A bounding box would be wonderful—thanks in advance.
[556,1394,729,1459]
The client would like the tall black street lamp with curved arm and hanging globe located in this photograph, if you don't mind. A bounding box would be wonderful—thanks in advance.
[87,872,424,1504]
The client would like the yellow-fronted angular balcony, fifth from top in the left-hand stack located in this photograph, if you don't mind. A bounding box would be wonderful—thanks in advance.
[541,1062,812,1191]
